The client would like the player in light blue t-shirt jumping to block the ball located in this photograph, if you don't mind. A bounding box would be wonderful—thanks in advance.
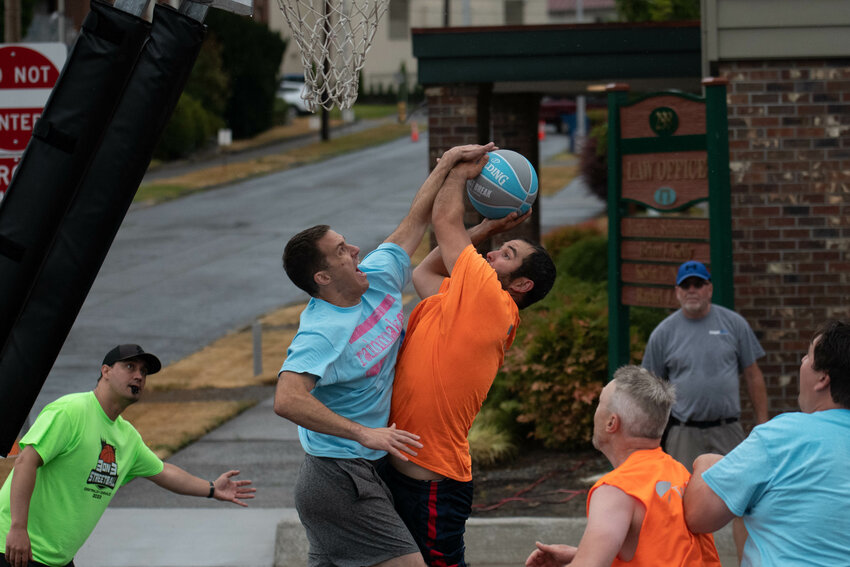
[274,143,495,567]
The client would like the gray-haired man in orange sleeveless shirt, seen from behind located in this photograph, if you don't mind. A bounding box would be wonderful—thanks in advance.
[525,366,720,567]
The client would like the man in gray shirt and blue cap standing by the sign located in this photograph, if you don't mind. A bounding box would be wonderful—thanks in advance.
[643,261,767,470]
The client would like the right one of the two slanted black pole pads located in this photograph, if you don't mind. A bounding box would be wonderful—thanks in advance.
[0,4,206,455]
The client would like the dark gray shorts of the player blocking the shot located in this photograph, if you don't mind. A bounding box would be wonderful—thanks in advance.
[295,455,419,567]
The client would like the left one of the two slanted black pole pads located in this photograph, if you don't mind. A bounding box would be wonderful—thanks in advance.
[0,0,150,360]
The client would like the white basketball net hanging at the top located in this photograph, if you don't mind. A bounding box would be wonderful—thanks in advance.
[278,0,389,112]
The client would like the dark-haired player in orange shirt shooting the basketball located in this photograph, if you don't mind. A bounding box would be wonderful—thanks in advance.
[383,152,555,567]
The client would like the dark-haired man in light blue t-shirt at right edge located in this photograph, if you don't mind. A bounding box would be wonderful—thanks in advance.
[685,321,850,566]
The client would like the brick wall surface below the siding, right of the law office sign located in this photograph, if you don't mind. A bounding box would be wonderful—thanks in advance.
[719,60,850,418]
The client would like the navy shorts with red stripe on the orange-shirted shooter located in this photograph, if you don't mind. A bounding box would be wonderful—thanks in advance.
[378,459,472,567]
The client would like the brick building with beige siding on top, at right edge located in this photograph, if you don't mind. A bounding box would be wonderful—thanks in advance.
[703,0,850,415]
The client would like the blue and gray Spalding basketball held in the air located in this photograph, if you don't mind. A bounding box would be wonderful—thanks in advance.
[466,150,537,219]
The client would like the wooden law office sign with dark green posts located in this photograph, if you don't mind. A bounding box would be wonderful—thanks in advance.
[607,78,734,379]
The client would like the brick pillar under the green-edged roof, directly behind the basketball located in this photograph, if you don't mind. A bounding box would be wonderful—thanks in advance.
[425,85,540,246]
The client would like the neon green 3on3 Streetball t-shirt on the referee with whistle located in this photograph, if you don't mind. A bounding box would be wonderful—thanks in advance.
[0,392,163,567]
